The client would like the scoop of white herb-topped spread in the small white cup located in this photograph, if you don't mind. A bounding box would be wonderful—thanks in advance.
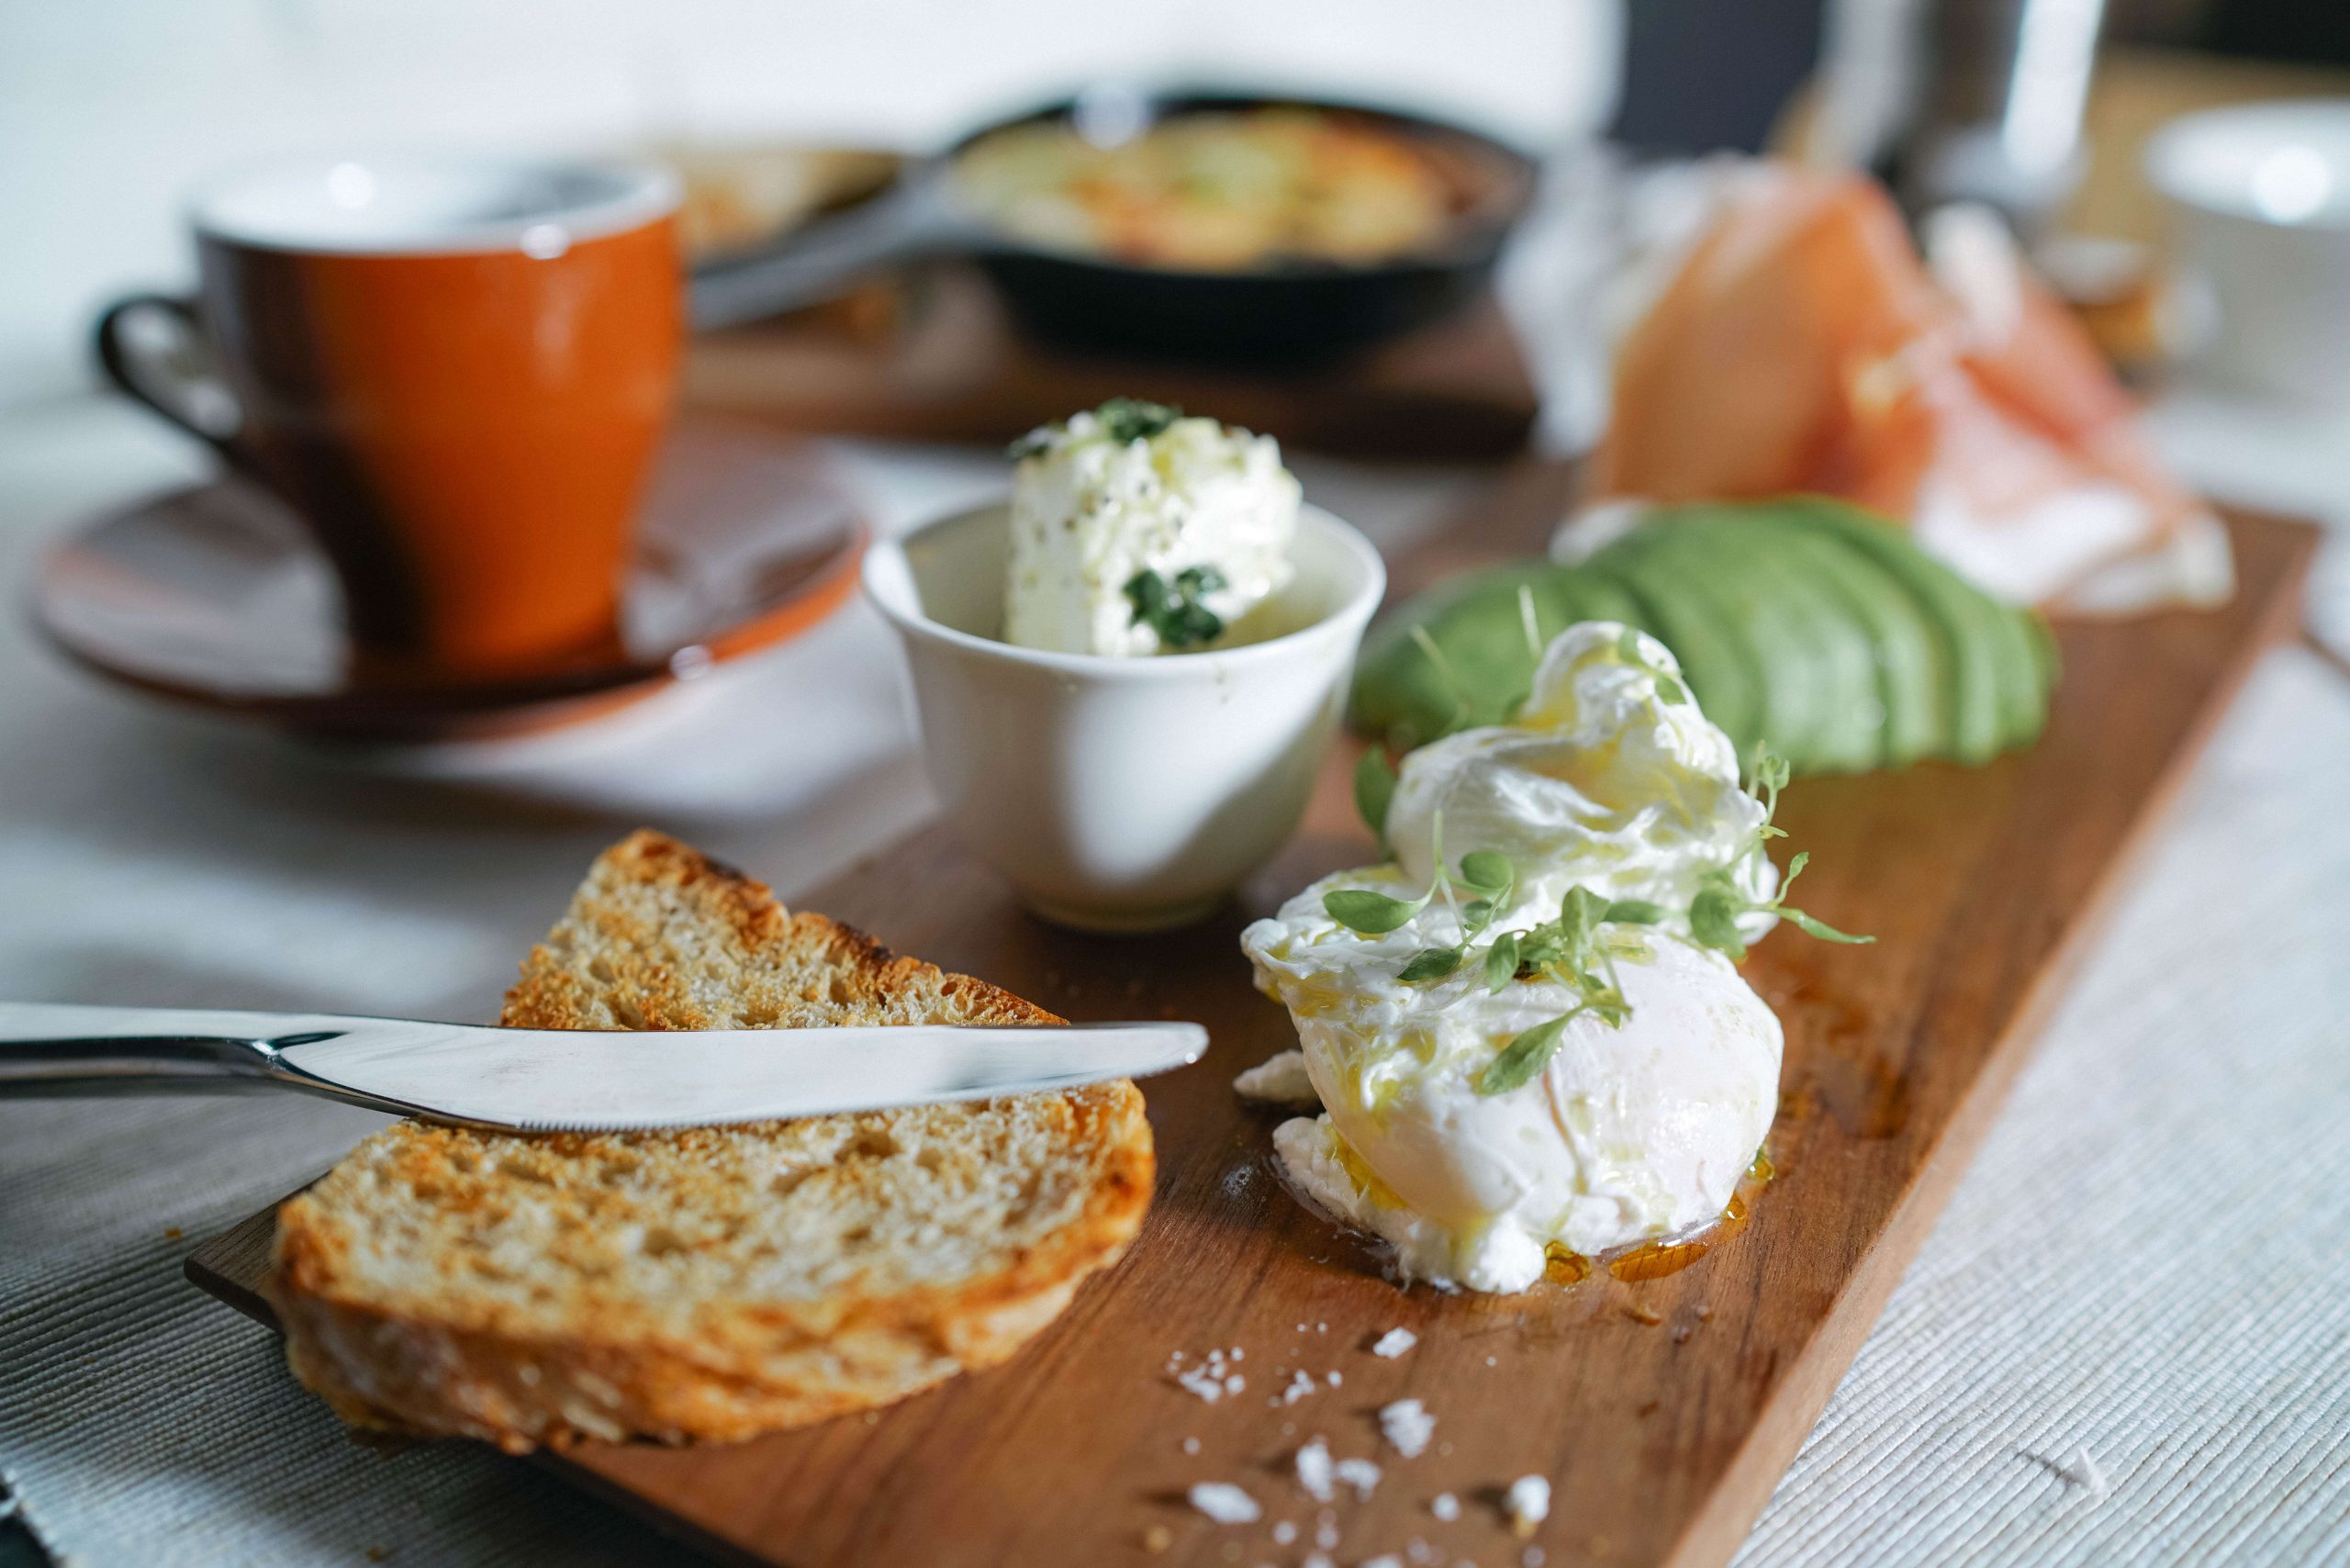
[1003,404,1300,658]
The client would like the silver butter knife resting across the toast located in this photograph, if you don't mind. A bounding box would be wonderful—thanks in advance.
[0,1002,1208,1133]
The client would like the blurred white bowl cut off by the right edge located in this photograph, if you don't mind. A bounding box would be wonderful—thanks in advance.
[2145,99,2350,404]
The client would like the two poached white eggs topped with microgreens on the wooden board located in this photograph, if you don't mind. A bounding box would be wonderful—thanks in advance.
[1241,623,1781,1291]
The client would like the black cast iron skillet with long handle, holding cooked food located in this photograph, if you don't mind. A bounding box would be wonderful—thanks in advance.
[693,87,1535,364]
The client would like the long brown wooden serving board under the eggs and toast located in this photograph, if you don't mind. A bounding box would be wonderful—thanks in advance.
[188,479,2315,1568]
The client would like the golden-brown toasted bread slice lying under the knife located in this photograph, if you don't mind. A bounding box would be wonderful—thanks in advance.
[263,832,1151,1453]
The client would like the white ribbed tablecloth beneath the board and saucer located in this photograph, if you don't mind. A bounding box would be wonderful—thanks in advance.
[0,404,2350,1568]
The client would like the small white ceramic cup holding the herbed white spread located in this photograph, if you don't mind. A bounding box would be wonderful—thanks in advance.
[865,506,1386,931]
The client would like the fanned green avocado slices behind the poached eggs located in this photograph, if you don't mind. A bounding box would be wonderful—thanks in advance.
[1354,496,2056,771]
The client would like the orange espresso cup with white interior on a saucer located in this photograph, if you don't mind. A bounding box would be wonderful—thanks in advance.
[99,158,684,679]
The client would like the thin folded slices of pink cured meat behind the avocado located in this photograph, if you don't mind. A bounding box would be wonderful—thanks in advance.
[1562,164,2232,613]
